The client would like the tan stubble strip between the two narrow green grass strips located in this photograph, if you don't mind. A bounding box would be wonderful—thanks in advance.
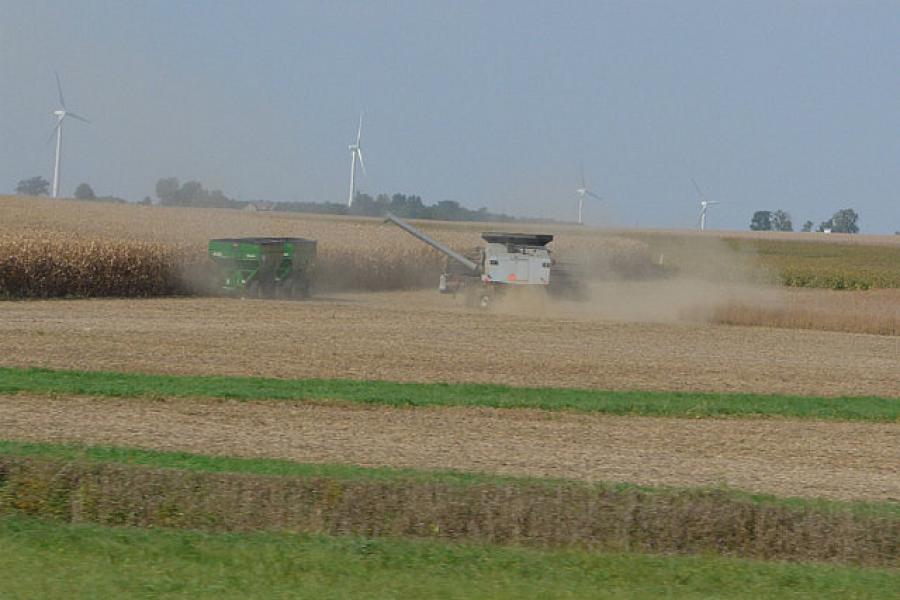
[0,395,900,500]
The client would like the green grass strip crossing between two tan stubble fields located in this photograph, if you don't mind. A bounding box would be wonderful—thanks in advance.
[0,367,900,422]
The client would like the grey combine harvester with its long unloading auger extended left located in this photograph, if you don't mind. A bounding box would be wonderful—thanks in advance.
[386,213,576,306]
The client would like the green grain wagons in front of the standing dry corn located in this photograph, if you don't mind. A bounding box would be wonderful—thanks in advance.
[209,237,316,298]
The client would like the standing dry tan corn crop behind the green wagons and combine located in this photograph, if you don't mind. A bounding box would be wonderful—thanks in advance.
[0,197,649,297]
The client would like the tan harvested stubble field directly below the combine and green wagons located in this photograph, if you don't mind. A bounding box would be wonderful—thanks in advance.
[0,291,900,397]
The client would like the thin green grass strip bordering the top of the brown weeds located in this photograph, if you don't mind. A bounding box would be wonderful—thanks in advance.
[0,440,900,518]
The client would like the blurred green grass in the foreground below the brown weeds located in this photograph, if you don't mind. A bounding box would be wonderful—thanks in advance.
[0,517,900,600]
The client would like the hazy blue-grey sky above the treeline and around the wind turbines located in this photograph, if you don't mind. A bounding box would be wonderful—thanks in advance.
[0,0,900,233]
